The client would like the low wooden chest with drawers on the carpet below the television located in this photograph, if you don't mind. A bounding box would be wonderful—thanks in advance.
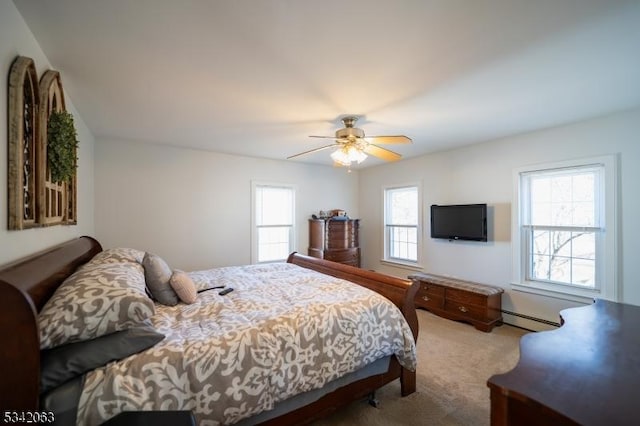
[409,273,504,332]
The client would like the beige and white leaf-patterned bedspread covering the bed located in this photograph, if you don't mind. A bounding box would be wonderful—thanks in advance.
[78,263,416,425]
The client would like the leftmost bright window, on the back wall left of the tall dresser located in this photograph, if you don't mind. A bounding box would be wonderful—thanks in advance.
[253,184,295,263]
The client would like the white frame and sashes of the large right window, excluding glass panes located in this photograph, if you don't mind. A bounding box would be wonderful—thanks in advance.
[511,155,620,303]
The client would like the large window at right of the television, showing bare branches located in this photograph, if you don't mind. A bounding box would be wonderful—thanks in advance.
[514,157,617,300]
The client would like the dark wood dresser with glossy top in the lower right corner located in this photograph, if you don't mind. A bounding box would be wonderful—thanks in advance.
[487,300,640,426]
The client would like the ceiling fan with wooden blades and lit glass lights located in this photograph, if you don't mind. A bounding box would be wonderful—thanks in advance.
[287,116,411,167]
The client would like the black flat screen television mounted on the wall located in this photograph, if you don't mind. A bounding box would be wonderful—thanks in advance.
[431,204,487,241]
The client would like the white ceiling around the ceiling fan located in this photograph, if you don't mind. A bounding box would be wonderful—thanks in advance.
[15,0,640,166]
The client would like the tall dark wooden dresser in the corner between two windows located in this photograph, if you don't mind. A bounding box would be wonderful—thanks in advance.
[309,219,360,268]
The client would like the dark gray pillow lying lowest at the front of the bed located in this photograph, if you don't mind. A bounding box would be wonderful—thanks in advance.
[40,326,164,393]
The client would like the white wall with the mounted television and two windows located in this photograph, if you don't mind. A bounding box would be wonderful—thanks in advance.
[359,109,640,329]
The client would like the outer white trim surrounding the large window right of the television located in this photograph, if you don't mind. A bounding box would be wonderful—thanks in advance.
[511,155,620,303]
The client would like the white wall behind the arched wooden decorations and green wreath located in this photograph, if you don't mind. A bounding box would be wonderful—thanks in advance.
[0,0,94,264]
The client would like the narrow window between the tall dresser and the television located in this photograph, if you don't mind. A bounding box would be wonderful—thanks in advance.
[384,185,420,264]
